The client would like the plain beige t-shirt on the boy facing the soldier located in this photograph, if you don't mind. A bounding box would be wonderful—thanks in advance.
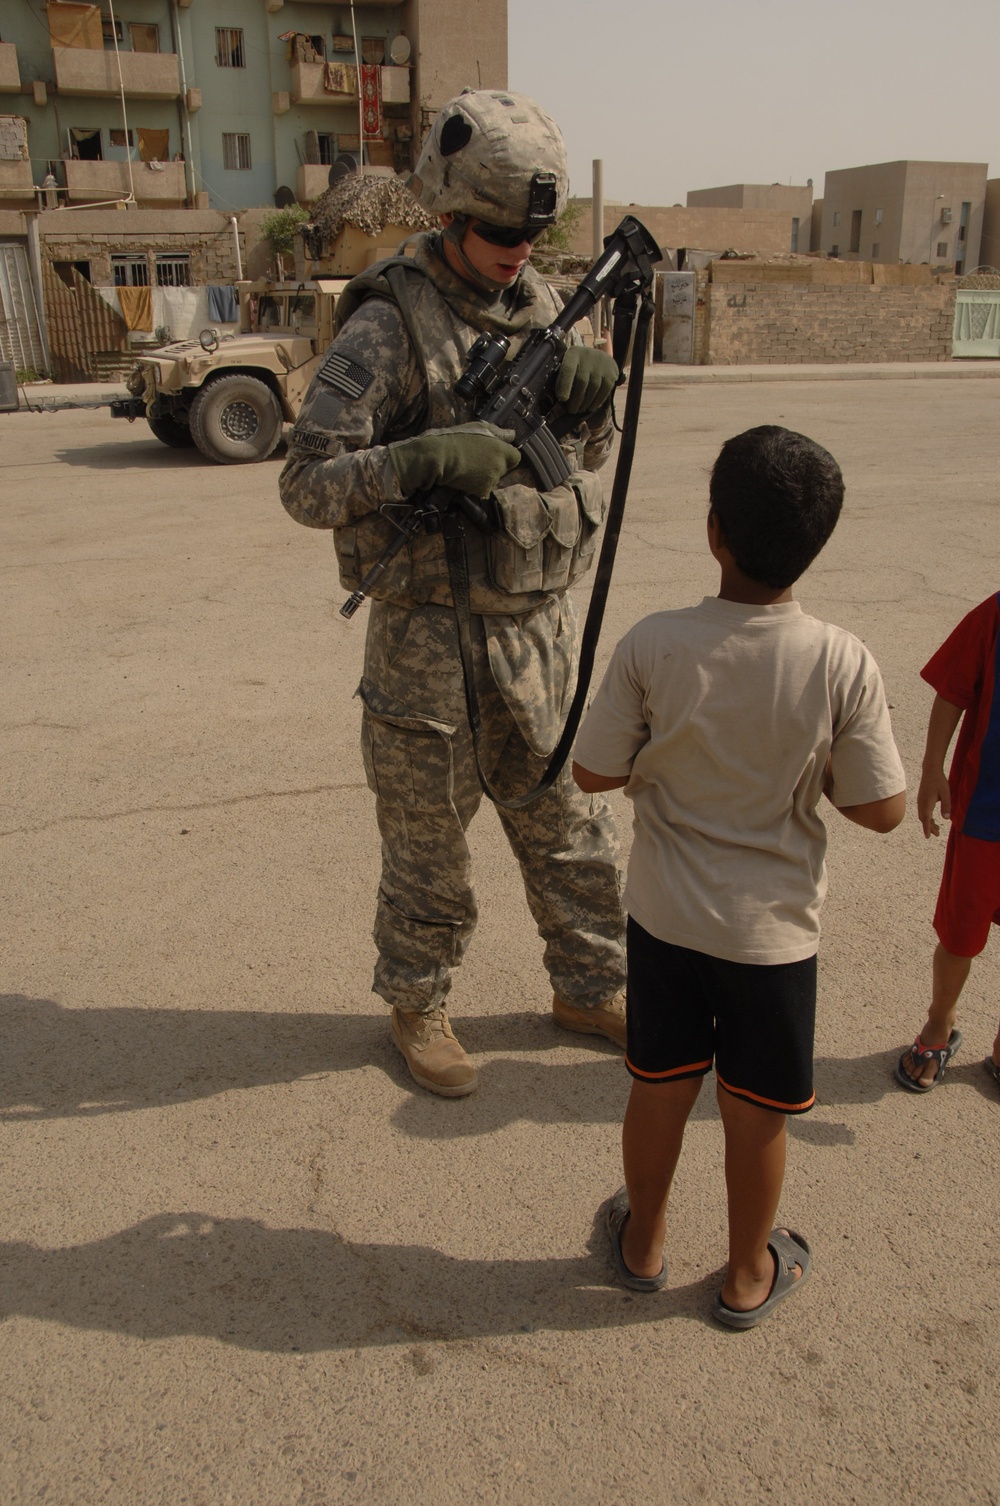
[574,596,905,964]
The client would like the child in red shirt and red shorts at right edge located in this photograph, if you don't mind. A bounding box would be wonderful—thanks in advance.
[896,595,1000,1093]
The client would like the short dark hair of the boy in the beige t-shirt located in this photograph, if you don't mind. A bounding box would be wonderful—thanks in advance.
[709,423,843,590]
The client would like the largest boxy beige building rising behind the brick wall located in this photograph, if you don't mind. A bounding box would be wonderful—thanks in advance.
[813,161,986,276]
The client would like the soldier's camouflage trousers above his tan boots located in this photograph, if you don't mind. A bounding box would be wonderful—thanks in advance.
[358,598,625,1011]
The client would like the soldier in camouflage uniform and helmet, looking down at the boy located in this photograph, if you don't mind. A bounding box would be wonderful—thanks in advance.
[280,90,625,1098]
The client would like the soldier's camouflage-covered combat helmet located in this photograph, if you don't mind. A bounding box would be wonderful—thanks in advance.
[410,89,569,230]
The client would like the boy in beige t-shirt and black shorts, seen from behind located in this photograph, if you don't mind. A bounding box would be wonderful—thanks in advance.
[574,426,905,1328]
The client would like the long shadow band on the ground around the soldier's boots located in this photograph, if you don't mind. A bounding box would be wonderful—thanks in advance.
[0,994,903,1148]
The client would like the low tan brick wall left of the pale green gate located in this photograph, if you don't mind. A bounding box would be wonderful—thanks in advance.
[699,262,955,366]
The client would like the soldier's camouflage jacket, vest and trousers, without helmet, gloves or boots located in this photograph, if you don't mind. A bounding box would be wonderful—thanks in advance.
[280,235,625,1012]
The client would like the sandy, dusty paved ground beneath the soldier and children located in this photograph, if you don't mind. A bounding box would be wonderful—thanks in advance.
[0,381,1000,1506]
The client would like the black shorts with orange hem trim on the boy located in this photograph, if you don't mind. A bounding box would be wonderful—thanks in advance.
[625,916,816,1114]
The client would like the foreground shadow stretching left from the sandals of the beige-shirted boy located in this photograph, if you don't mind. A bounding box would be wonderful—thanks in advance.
[0,1211,718,1355]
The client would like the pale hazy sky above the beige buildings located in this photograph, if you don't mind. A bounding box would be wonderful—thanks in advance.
[508,0,1000,205]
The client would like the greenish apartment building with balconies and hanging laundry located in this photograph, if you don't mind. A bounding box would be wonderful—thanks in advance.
[0,0,508,212]
